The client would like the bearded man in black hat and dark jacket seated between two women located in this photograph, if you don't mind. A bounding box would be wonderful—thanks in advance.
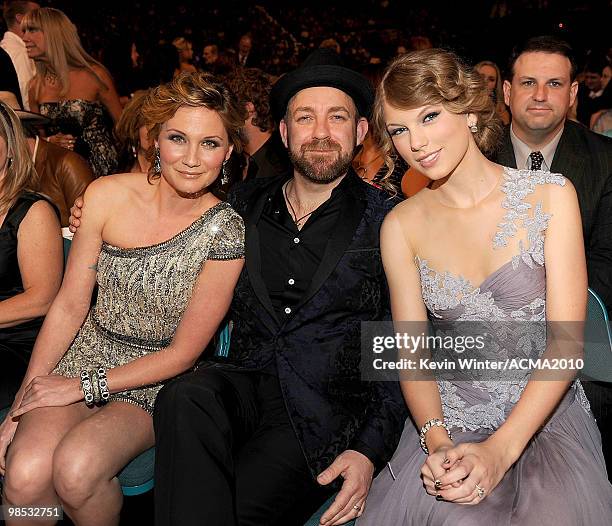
[155,52,407,526]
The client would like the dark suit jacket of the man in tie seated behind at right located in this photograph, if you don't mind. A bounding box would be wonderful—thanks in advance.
[496,121,612,312]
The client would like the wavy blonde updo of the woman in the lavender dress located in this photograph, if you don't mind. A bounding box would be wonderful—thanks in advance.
[372,49,503,188]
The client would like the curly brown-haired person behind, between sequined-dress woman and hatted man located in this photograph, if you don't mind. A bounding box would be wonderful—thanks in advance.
[227,68,291,180]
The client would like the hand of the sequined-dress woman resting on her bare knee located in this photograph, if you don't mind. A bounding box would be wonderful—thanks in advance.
[10,374,83,418]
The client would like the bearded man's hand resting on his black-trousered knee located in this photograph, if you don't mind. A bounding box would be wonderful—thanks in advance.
[317,449,374,526]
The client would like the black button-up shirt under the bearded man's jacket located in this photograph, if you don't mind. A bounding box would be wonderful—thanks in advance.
[258,178,346,321]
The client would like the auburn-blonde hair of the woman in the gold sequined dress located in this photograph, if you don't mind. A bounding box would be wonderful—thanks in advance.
[141,73,246,186]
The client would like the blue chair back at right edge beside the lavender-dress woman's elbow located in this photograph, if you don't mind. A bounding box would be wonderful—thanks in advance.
[580,289,612,382]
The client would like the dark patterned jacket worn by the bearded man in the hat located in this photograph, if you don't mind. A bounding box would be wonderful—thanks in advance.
[222,169,407,484]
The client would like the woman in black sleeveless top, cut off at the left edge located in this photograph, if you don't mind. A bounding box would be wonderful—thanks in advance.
[0,102,63,409]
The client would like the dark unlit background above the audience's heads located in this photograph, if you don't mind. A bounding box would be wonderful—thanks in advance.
[21,0,612,78]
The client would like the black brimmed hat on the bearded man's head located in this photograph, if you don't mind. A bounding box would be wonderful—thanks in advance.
[270,48,374,121]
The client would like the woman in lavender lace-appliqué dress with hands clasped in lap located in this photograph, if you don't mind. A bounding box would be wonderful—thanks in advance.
[358,49,612,526]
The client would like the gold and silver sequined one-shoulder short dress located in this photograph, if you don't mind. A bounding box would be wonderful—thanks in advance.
[53,202,244,414]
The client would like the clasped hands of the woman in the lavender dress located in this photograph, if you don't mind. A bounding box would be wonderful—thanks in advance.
[421,440,511,505]
